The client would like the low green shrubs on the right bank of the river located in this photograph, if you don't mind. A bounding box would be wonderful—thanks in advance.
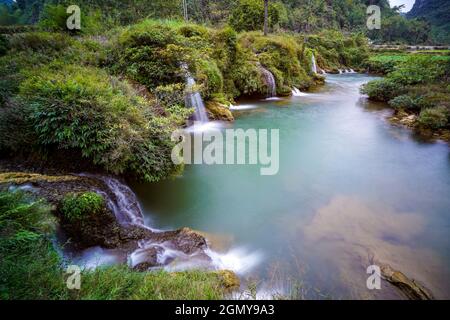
[363,53,450,132]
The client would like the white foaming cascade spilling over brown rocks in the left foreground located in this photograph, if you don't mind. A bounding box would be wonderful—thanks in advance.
[75,173,262,274]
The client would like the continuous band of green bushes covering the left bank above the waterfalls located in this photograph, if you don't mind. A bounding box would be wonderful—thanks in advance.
[0,15,368,181]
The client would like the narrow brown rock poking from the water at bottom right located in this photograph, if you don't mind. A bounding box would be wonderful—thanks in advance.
[381,264,433,300]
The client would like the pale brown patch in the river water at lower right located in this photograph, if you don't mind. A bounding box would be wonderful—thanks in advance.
[300,196,449,298]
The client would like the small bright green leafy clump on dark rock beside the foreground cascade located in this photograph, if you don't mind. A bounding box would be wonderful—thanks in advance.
[60,192,105,222]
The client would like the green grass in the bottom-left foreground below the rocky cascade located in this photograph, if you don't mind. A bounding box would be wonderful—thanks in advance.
[0,191,225,300]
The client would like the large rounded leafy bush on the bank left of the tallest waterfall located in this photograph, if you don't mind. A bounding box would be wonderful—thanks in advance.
[20,65,183,181]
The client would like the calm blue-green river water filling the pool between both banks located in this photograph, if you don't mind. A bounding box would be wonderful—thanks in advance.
[132,74,450,299]
